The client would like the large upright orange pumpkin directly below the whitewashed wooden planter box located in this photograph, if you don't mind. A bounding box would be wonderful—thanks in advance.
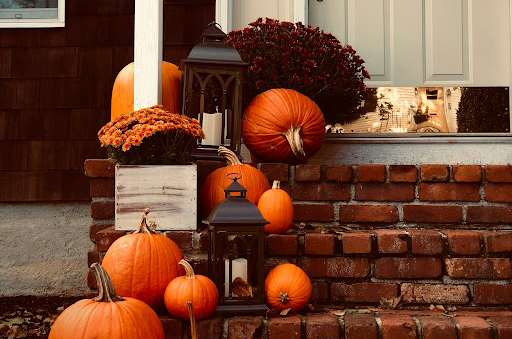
[103,209,185,309]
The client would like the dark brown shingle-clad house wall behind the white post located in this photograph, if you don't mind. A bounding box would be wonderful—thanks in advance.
[0,0,215,201]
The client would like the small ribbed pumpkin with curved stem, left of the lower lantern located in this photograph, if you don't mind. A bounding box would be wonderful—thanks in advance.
[164,260,219,319]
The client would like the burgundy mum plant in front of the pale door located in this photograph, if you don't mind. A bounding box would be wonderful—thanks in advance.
[227,18,370,123]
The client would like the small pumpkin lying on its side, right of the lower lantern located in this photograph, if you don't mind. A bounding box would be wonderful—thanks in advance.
[265,264,312,311]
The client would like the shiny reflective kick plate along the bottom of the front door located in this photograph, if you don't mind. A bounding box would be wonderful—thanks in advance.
[328,87,510,133]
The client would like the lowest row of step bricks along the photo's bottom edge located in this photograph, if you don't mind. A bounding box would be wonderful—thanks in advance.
[160,310,512,339]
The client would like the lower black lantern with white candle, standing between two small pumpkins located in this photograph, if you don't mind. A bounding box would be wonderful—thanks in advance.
[203,173,268,313]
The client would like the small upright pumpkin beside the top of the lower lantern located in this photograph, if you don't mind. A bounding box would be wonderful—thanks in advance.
[258,180,293,233]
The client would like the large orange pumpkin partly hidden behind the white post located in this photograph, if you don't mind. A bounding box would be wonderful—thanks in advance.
[110,61,182,120]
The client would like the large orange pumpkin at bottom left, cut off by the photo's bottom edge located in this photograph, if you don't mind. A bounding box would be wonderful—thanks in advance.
[48,263,164,339]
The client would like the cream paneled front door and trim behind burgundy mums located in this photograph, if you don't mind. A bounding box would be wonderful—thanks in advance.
[224,0,511,86]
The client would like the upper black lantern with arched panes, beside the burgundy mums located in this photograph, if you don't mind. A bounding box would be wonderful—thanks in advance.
[182,23,248,159]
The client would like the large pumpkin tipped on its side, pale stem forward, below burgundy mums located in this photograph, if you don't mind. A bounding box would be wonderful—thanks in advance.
[242,88,325,163]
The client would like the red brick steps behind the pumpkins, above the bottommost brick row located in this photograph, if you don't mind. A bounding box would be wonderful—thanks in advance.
[86,160,512,309]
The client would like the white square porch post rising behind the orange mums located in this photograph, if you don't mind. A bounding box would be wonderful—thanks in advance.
[133,0,163,110]
